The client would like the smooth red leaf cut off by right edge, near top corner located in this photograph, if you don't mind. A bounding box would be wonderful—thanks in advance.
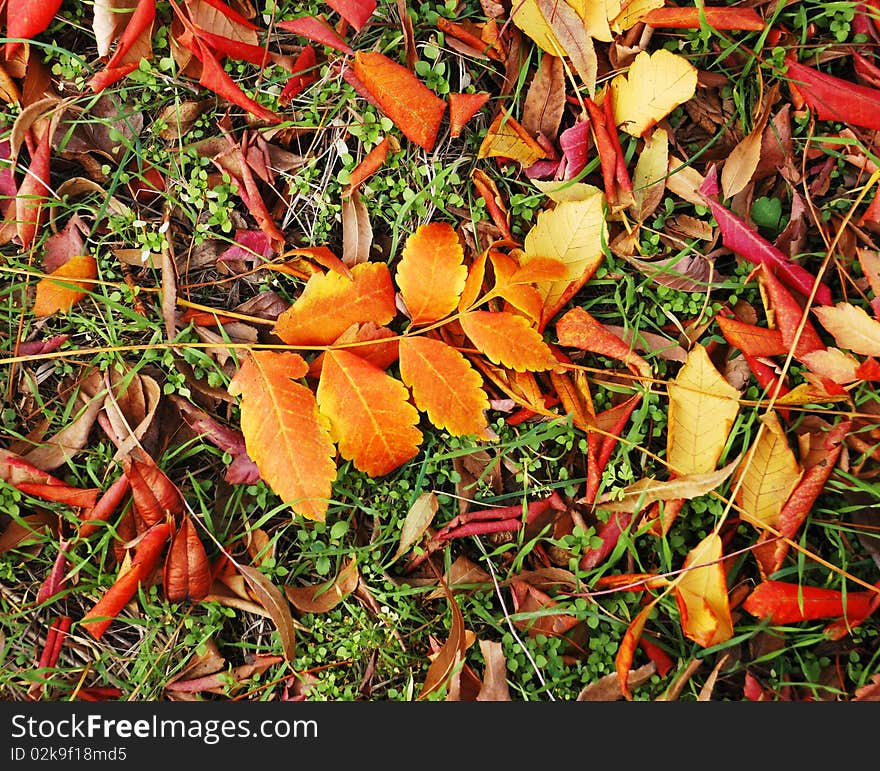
[785,57,880,129]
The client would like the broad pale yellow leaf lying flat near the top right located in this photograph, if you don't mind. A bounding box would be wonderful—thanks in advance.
[611,48,697,137]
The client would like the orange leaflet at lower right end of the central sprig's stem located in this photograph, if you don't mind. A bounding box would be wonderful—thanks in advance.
[461,311,558,372]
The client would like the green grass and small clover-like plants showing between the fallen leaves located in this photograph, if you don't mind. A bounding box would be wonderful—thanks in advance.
[0,2,880,701]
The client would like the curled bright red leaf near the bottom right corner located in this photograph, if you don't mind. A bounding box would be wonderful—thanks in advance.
[742,581,874,624]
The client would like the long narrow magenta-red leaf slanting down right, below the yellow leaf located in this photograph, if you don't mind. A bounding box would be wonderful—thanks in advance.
[700,169,831,305]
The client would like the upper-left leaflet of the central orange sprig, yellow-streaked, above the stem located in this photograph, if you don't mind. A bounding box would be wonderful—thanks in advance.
[274,262,397,345]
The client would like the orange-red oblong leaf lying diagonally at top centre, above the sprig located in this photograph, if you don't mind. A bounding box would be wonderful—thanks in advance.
[353,51,446,152]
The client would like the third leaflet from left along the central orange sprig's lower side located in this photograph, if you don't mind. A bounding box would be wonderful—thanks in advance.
[399,337,489,439]
